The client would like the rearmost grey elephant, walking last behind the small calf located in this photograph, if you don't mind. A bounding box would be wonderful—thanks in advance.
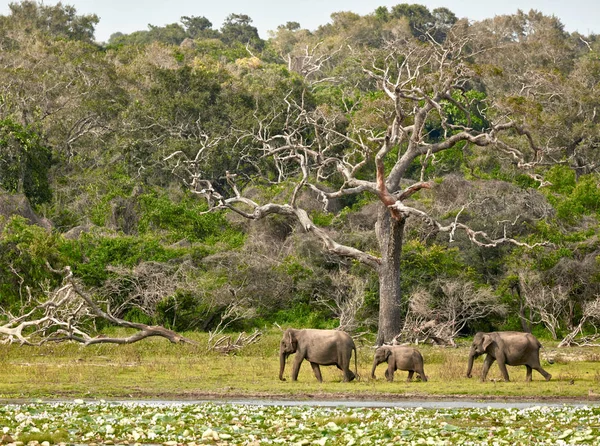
[467,331,552,382]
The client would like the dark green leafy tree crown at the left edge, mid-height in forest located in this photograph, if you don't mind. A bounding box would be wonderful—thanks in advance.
[0,118,52,205]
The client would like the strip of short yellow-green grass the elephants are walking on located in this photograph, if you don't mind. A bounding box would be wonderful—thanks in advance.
[0,331,600,400]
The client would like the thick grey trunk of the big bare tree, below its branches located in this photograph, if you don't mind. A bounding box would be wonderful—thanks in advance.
[376,205,405,345]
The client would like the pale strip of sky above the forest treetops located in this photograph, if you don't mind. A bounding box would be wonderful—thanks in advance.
[0,0,600,42]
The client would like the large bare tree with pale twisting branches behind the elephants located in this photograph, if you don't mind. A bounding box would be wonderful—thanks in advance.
[168,23,556,344]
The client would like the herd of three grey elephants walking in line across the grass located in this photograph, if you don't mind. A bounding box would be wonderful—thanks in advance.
[279,328,552,382]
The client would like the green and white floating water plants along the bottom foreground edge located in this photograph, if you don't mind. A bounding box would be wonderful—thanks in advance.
[0,400,600,446]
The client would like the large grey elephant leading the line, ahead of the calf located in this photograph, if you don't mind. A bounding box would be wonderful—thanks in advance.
[279,328,358,382]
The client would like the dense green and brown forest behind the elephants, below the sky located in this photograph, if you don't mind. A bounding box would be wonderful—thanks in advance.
[0,1,600,345]
